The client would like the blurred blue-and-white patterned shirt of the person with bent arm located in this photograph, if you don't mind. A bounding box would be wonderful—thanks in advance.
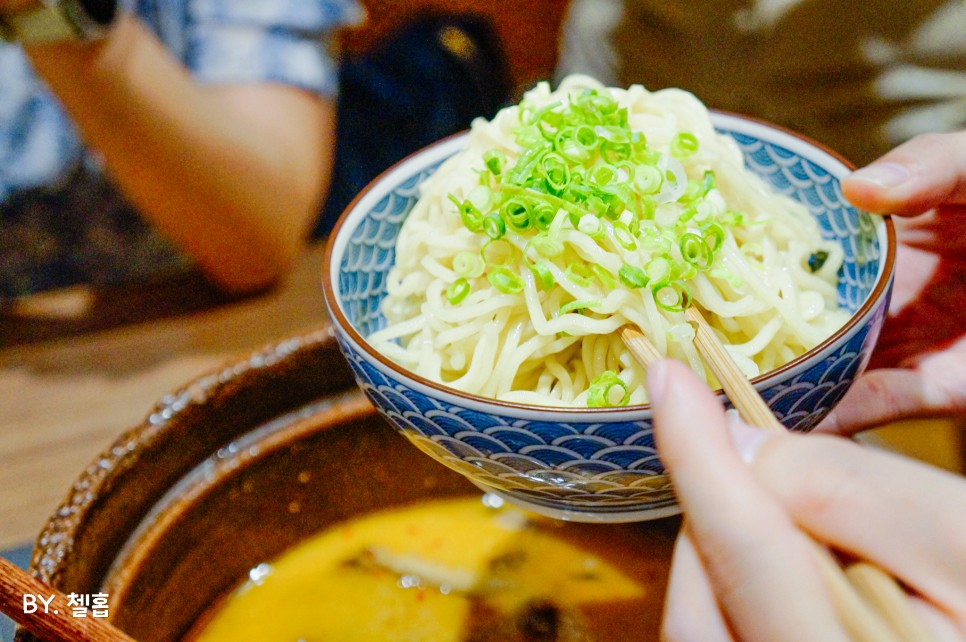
[0,0,363,297]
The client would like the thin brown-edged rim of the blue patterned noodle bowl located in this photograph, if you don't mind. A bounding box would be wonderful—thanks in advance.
[322,109,897,421]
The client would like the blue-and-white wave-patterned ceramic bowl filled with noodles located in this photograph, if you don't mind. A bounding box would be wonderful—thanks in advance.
[323,113,895,522]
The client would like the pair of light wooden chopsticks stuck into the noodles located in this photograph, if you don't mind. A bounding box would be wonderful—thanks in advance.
[619,306,933,642]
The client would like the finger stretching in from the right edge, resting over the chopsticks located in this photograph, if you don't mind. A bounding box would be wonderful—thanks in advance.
[752,428,966,620]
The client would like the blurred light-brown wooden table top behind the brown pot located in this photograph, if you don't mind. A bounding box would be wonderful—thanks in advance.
[0,239,962,549]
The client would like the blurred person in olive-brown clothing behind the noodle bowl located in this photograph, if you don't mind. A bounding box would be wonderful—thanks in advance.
[558,0,966,164]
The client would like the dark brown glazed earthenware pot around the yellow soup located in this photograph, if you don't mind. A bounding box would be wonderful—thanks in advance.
[16,328,678,642]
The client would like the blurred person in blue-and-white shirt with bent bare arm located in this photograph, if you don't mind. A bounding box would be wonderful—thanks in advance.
[0,0,363,299]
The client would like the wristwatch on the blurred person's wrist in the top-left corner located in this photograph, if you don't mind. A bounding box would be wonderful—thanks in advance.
[0,0,118,44]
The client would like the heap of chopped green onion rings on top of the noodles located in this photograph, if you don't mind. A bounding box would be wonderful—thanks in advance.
[447,89,744,318]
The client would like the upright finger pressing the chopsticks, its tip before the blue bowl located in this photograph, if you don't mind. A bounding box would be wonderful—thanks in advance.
[648,360,846,641]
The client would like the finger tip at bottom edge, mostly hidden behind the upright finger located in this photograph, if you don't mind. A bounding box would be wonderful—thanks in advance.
[661,528,733,642]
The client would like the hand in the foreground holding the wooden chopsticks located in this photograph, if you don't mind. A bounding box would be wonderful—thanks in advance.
[648,360,966,642]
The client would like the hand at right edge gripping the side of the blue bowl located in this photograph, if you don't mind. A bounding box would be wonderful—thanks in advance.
[818,132,966,434]
